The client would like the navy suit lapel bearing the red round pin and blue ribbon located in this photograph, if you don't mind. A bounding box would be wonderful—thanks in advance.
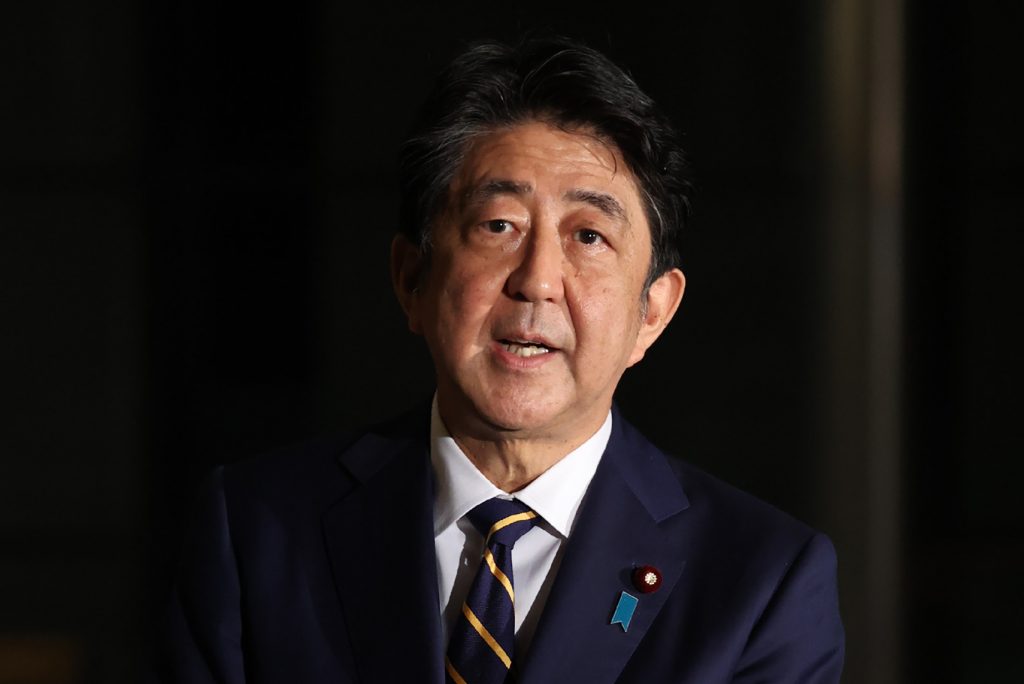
[519,412,688,684]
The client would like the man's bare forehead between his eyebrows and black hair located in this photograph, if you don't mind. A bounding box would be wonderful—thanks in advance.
[451,121,643,214]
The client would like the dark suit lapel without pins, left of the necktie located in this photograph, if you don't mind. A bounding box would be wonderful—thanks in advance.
[324,413,443,684]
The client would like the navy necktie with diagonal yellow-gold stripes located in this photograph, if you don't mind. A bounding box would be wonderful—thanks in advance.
[444,499,539,684]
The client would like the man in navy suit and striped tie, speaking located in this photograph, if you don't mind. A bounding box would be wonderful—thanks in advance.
[164,40,843,684]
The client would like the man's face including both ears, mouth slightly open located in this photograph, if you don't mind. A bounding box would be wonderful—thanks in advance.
[396,122,682,441]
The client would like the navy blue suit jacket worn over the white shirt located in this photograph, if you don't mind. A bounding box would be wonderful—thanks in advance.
[161,413,843,684]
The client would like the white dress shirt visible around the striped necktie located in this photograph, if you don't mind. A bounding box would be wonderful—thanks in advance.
[430,397,611,654]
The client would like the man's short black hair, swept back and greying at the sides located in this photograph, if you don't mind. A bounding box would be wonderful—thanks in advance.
[399,36,692,290]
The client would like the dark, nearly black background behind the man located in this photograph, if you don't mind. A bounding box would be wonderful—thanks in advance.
[0,0,1024,684]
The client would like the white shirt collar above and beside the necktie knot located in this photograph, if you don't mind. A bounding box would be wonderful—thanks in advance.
[430,396,611,539]
